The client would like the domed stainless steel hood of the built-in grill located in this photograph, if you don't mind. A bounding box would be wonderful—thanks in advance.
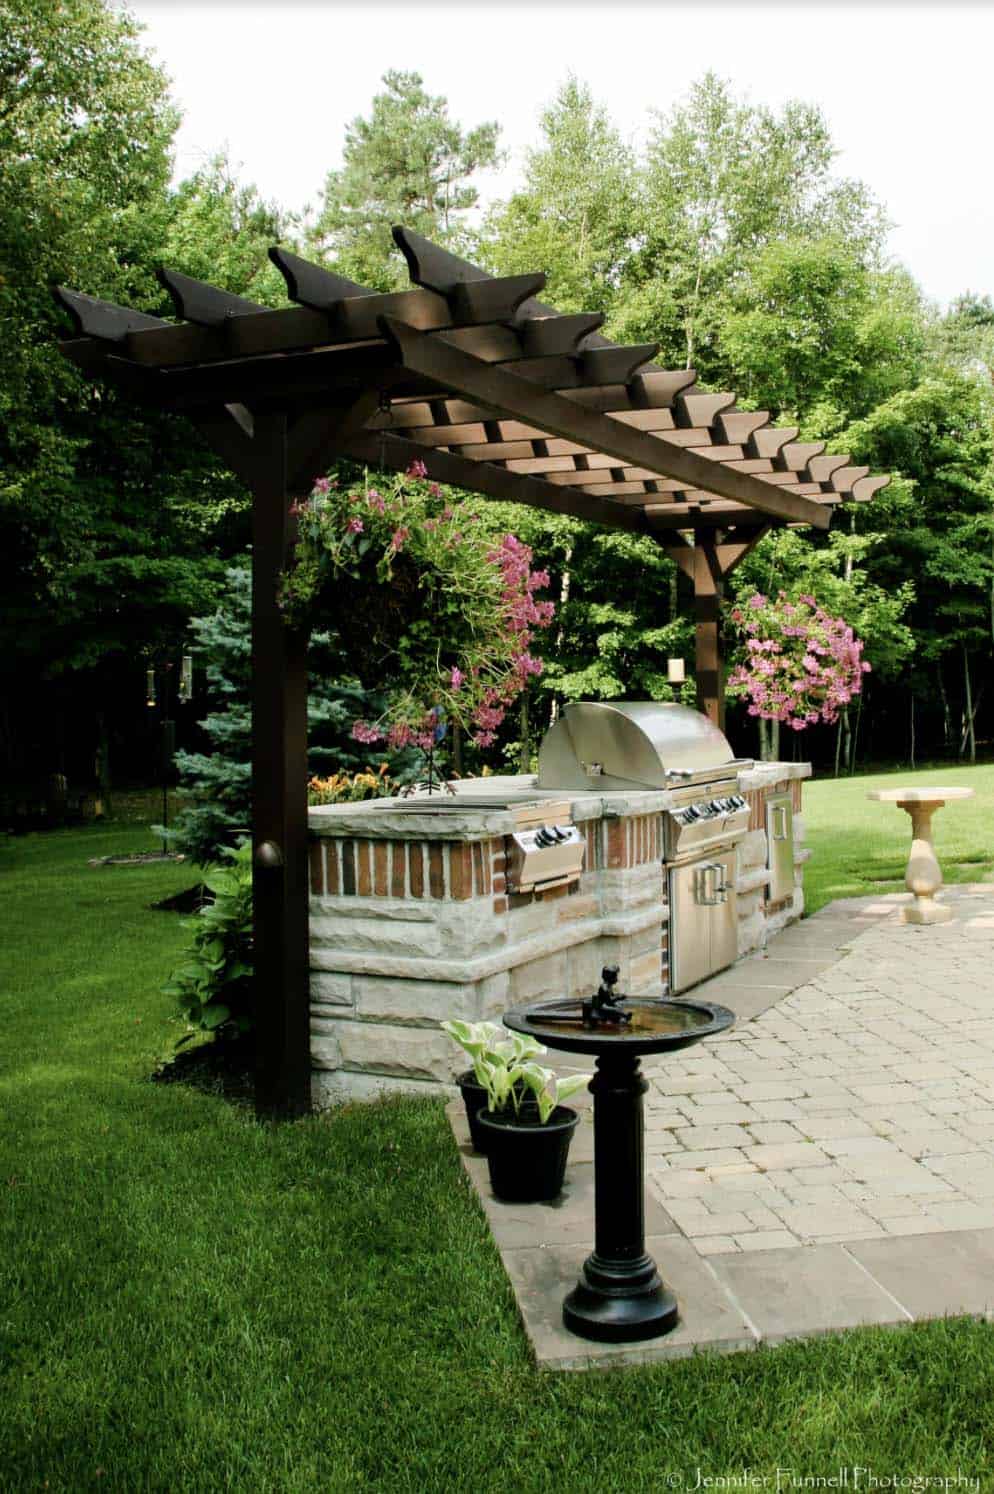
[537,701,738,790]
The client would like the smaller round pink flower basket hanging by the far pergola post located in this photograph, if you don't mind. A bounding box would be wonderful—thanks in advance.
[728,592,870,732]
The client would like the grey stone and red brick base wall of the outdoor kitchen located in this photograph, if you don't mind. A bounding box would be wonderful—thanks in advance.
[309,763,810,1106]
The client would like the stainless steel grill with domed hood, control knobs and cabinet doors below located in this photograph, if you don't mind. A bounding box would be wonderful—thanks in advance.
[538,701,752,991]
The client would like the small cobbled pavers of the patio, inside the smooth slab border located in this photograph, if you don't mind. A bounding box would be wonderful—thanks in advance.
[647,884,994,1253]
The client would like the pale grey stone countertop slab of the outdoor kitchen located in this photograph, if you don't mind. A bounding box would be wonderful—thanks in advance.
[308,762,812,841]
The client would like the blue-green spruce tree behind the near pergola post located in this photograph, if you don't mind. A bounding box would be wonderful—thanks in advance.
[170,562,420,865]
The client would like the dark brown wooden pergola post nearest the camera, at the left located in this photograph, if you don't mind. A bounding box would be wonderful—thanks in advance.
[251,414,311,1118]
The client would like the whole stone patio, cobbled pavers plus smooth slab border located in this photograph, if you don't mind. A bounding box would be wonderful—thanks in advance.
[450,883,994,1369]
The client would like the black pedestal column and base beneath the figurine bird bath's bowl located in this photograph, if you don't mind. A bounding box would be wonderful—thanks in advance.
[562,1052,677,1343]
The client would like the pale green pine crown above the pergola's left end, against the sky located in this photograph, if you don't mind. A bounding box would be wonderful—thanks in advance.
[311,72,499,290]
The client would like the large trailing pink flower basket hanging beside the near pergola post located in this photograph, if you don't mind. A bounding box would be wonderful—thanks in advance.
[281,460,553,750]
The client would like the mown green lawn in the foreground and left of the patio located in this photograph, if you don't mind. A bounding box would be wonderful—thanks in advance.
[0,818,994,1494]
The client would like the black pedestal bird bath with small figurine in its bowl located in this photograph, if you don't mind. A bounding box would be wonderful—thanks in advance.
[504,967,735,1343]
